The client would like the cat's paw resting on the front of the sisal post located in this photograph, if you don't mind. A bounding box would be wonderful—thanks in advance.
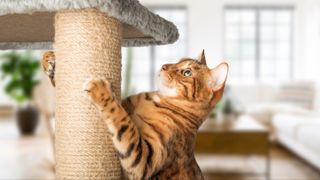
[84,79,113,104]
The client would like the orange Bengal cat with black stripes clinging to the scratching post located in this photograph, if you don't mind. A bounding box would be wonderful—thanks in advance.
[42,51,228,180]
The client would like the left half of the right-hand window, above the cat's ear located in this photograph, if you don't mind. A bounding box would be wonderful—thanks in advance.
[225,9,256,80]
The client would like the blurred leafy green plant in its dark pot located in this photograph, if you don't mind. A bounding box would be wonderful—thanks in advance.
[0,51,40,135]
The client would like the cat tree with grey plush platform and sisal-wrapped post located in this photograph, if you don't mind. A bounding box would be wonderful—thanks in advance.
[0,0,179,179]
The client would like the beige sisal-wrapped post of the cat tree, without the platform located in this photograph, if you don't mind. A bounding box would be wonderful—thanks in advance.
[54,9,122,179]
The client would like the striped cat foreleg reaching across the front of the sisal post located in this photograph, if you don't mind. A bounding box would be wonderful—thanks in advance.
[85,79,153,179]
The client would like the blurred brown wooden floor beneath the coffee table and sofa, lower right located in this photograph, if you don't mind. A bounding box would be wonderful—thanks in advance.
[197,145,320,180]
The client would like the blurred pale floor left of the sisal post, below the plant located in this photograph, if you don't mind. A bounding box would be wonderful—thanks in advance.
[0,120,54,180]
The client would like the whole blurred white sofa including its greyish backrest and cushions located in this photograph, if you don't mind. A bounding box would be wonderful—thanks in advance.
[231,81,320,170]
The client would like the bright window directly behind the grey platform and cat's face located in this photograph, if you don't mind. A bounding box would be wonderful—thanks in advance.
[122,7,187,96]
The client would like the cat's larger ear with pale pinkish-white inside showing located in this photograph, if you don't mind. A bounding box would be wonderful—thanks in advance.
[210,62,229,92]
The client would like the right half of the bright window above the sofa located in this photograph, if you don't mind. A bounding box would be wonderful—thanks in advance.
[259,9,292,80]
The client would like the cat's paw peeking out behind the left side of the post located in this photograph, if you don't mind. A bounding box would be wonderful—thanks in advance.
[41,51,56,86]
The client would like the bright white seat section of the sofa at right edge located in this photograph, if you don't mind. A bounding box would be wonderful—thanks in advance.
[272,113,320,170]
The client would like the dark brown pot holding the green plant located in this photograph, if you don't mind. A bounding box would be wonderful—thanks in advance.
[17,106,39,135]
